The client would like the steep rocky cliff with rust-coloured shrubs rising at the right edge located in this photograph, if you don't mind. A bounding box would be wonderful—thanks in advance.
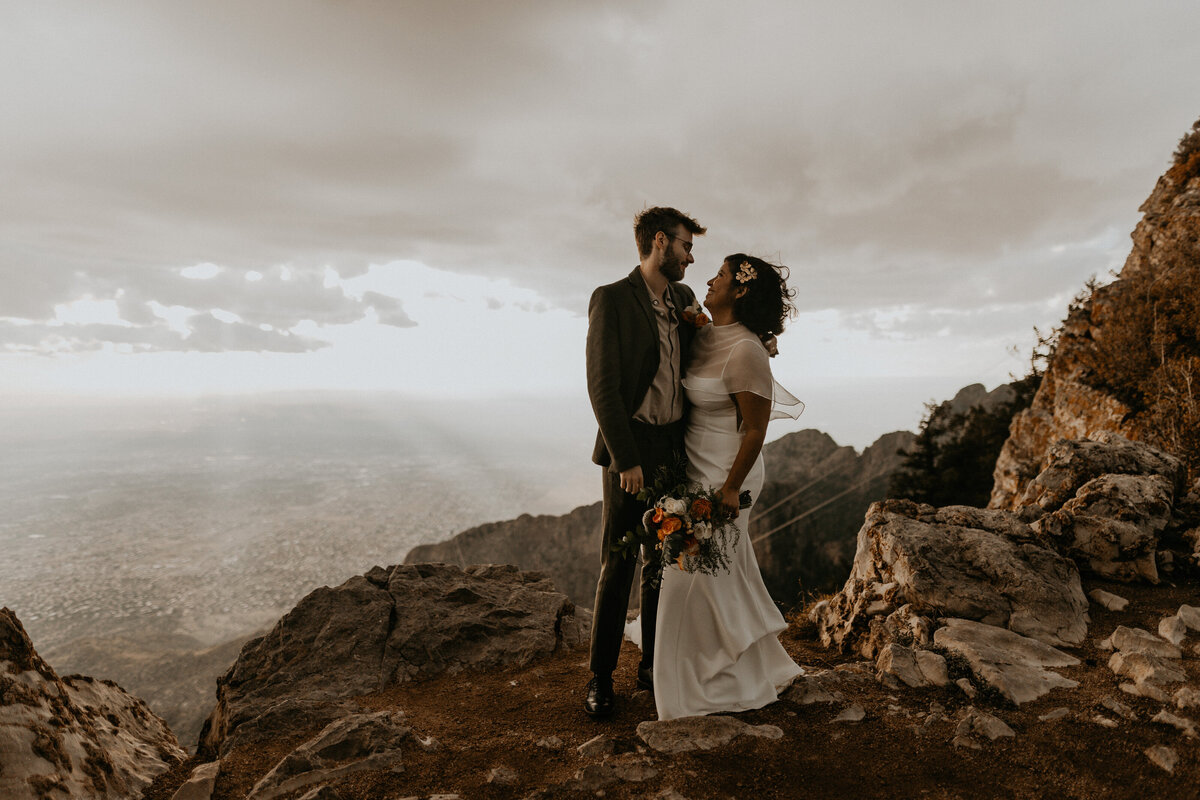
[989,121,1200,509]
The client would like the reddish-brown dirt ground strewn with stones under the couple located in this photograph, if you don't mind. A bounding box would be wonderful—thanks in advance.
[145,581,1200,800]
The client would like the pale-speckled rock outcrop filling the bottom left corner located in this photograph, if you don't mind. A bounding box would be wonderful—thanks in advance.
[0,608,186,800]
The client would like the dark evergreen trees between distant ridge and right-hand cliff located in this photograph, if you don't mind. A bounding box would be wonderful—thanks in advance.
[888,376,1052,507]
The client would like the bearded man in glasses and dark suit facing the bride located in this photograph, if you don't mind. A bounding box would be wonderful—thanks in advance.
[584,207,706,717]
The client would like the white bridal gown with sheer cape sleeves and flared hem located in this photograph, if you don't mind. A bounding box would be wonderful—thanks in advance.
[654,323,803,720]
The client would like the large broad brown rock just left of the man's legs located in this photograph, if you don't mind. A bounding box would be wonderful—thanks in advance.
[200,564,588,757]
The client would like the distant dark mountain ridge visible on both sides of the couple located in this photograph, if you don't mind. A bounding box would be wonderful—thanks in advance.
[404,429,913,608]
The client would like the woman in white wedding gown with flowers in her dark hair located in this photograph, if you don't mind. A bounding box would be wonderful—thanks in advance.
[654,253,804,720]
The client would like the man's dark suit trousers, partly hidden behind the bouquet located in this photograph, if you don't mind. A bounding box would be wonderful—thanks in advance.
[592,421,684,675]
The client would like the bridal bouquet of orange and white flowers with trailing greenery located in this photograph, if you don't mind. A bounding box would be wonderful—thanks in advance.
[614,460,750,585]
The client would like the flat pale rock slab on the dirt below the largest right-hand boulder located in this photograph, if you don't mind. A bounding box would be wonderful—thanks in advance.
[934,619,1079,705]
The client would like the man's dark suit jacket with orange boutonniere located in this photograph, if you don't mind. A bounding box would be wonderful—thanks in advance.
[587,267,696,472]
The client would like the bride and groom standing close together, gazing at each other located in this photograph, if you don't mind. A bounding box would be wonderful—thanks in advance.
[584,207,803,720]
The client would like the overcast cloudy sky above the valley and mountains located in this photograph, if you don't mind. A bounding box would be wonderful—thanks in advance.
[0,0,1200,446]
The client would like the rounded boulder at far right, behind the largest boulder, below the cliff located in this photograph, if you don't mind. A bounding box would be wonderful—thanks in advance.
[1033,474,1174,583]
